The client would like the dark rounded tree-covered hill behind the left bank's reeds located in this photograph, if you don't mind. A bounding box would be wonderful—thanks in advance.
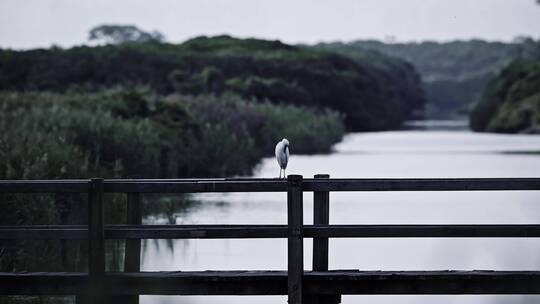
[0,36,425,131]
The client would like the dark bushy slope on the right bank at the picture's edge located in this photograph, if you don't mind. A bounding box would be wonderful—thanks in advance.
[470,60,540,133]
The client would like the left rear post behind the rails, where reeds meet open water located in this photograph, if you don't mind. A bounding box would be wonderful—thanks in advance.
[122,193,142,304]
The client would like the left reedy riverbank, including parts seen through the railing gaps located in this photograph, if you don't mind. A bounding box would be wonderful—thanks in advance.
[0,88,345,282]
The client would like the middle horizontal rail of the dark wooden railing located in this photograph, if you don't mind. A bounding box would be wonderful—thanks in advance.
[0,224,540,240]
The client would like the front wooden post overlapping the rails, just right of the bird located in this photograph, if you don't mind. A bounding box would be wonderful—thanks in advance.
[287,175,304,304]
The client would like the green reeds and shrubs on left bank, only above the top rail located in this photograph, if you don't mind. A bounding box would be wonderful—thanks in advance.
[0,88,344,179]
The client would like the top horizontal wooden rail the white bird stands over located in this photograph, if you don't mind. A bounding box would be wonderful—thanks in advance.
[0,178,540,194]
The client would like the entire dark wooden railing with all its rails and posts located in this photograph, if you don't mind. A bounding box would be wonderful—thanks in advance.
[0,175,540,304]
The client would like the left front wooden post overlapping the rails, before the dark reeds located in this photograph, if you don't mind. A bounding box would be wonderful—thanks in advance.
[87,178,105,303]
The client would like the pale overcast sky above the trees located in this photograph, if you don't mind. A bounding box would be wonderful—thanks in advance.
[0,0,540,49]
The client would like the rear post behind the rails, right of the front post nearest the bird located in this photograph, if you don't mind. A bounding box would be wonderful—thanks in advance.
[308,174,341,304]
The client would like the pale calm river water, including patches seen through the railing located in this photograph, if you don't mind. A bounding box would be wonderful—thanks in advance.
[141,130,540,304]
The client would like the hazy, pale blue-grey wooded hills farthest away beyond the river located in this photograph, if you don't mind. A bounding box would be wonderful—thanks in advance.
[319,38,538,119]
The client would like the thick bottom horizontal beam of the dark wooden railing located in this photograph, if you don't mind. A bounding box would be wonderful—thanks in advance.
[4,270,540,294]
